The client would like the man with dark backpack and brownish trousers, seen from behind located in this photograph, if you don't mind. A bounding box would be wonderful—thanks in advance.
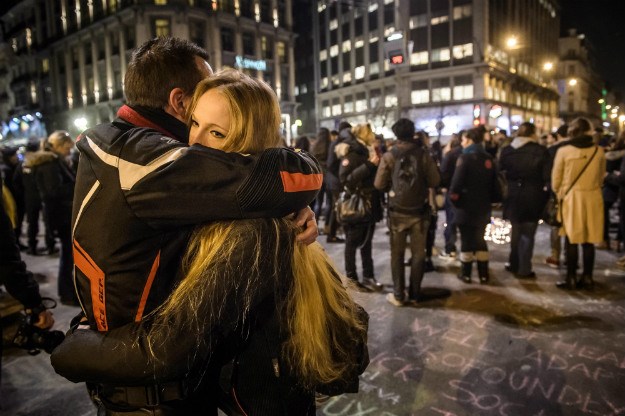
[374,118,441,306]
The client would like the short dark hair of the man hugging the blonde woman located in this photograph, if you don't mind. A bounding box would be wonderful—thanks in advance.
[124,37,208,109]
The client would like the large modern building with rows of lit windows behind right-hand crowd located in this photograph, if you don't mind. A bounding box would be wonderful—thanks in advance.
[313,0,560,137]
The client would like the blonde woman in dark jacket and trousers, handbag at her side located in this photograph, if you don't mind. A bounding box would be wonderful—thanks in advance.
[335,124,383,291]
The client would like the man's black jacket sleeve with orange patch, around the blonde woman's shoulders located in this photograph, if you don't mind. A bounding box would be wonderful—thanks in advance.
[120,145,323,227]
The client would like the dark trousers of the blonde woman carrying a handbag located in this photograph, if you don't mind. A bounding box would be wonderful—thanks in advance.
[343,222,375,281]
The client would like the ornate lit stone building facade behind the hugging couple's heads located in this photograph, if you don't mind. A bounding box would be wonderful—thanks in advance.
[0,0,295,141]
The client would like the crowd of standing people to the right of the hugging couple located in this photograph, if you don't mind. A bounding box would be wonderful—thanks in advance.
[297,114,625,306]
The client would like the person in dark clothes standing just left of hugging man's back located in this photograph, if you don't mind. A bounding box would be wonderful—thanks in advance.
[32,130,78,306]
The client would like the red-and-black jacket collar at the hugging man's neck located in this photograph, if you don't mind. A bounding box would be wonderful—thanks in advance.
[117,105,189,143]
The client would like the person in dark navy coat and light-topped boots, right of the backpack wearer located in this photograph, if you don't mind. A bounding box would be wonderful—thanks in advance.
[449,127,501,283]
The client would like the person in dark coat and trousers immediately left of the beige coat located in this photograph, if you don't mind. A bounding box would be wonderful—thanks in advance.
[499,122,551,278]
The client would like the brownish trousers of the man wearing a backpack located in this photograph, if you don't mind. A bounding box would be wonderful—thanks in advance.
[390,214,430,301]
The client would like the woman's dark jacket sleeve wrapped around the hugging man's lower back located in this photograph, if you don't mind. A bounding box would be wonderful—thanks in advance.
[50,219,276,386]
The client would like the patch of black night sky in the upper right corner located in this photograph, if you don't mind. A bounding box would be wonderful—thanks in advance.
[561,0,625,99]
